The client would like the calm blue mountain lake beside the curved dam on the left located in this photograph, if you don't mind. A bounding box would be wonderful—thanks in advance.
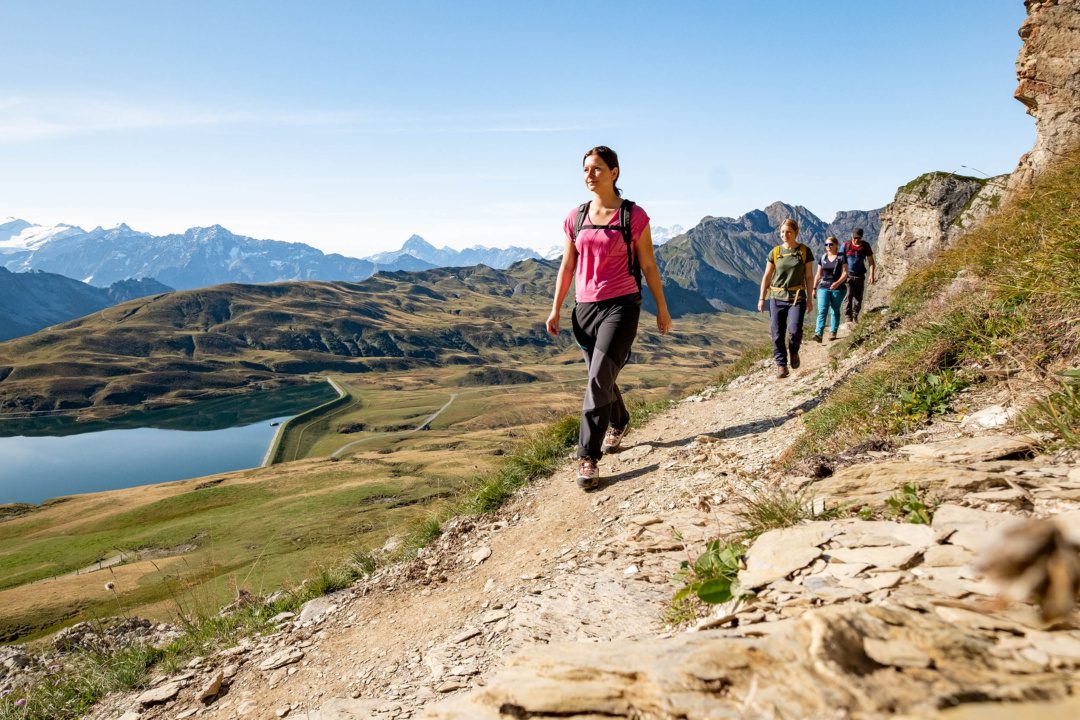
[0,383,337,504]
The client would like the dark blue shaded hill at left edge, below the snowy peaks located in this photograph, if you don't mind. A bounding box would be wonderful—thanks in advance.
[0,268,172,340]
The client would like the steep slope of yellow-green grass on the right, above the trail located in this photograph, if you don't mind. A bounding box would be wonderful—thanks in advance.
[786,151,1080,462]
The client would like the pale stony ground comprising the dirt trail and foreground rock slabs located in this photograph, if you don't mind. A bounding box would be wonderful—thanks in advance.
[46,330,1080,720]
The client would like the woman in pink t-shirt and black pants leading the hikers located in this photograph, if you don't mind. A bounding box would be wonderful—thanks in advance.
[548,146,672,490]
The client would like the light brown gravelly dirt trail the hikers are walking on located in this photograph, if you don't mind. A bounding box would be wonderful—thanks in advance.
[113,334,835,720]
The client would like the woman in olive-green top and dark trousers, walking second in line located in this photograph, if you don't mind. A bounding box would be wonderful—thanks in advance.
[757,218,813,378]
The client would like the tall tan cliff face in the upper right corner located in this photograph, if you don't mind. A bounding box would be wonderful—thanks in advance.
[1009,0,1080,193]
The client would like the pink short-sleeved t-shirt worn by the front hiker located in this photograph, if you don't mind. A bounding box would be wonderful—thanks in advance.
[563,205,649,302]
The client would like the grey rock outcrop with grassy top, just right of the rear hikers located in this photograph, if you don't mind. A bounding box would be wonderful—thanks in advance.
[867,173,1007,308]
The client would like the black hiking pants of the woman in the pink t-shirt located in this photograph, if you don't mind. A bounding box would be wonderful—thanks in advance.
[571,293,642,460]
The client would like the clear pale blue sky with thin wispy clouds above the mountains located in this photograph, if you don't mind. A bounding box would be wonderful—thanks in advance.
[0,0,1035,256]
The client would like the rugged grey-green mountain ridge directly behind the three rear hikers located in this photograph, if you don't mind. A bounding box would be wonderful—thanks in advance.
[657,202,880,310]
